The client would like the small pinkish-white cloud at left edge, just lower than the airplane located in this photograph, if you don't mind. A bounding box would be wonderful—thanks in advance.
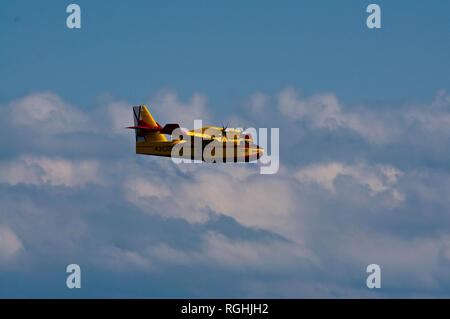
[0,156,101,187]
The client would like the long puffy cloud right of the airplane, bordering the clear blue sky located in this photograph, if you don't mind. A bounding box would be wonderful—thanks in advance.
[277,88,450,145]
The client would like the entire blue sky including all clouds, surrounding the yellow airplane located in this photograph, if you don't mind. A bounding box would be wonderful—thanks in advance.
[0,0,450,298]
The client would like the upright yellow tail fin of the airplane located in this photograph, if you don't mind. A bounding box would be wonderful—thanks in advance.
[133,105,167,142]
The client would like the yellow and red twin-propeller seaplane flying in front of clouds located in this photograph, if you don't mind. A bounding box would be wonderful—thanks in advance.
[128,105,264,163]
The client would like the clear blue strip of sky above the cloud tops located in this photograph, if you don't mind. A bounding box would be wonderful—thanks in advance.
[0,1,450,108]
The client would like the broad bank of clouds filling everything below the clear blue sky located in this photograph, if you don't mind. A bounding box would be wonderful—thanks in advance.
[0,88,450,297]
